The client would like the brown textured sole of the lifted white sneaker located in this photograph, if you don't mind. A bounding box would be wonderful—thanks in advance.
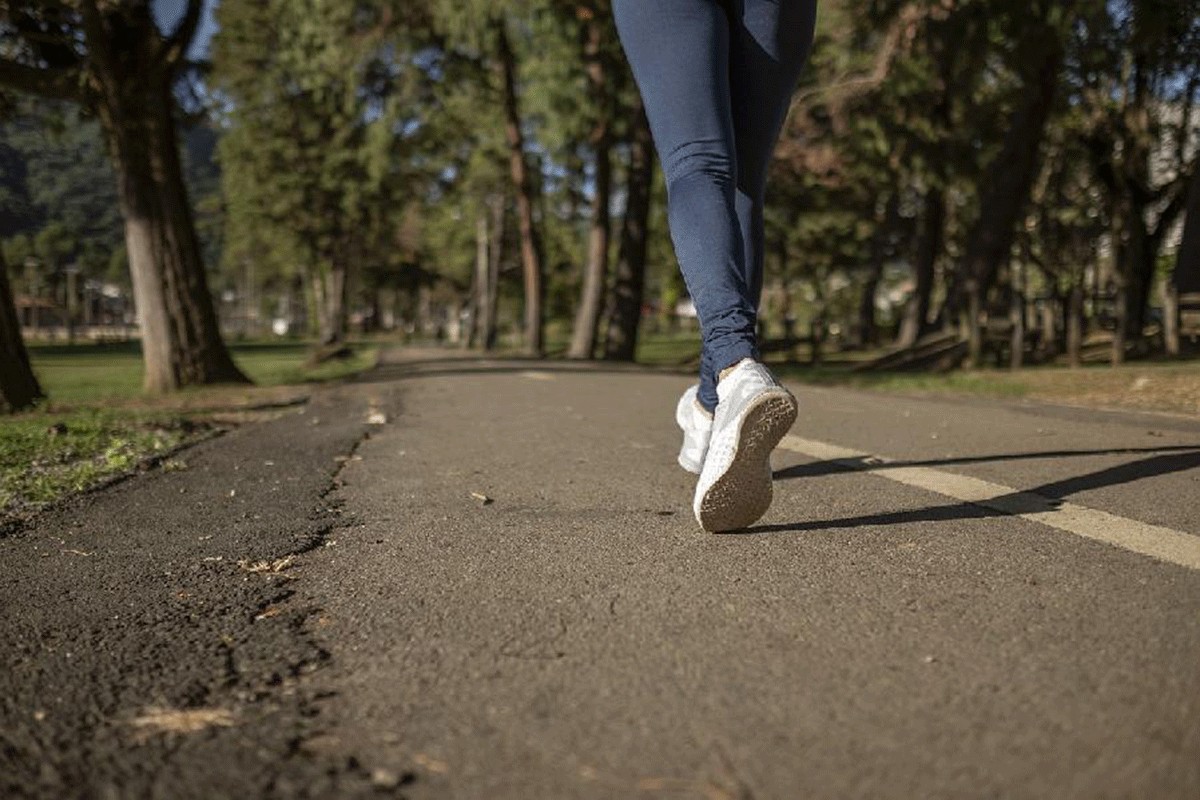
[696,391,798,533]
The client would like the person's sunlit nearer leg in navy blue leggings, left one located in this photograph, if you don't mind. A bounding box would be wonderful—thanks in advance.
[613,0,757,411]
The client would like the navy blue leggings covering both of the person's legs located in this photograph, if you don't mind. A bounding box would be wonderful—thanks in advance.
[612,0,816,411]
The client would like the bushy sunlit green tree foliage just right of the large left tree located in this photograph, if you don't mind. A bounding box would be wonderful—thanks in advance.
[214,0,437,331]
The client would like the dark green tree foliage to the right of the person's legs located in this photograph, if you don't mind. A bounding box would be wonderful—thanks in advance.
[768,0,1200,352]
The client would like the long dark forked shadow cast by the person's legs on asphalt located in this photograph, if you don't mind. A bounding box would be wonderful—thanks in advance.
[728,445,1200,535]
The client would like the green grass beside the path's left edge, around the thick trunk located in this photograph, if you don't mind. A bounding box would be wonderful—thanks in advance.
[0,342,378,524]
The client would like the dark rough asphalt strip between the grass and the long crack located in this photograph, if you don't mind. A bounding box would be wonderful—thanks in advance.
[0,390,407,799]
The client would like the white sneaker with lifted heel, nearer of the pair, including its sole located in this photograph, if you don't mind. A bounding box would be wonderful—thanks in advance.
[692,359,798,531]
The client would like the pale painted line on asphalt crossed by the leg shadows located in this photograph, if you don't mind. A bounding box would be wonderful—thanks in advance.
[779,434,1200,570]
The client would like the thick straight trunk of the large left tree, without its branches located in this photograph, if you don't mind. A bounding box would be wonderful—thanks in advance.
[89,28,247,392]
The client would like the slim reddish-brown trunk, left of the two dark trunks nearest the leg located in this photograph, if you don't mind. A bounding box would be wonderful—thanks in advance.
[492,16,545,356]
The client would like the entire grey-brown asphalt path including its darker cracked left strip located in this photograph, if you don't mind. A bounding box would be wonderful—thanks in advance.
[0,354,1200,799]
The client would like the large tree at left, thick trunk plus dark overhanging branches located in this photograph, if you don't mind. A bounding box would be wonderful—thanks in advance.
[0,0,246,392]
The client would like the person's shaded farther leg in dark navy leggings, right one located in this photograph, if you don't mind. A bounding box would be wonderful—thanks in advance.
[730,0,816,308]
